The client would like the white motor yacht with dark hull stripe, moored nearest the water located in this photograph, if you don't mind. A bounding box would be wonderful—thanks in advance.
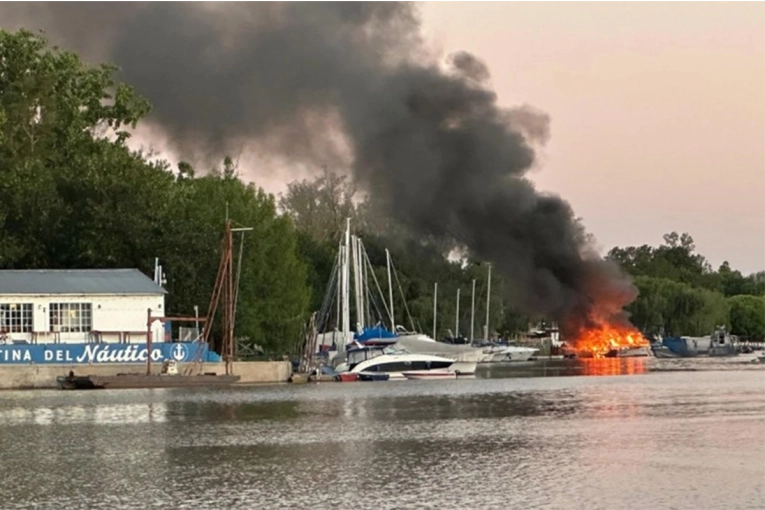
[336,346,476,379]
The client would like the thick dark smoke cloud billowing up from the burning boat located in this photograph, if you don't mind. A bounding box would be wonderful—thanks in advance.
[0,2,634,329]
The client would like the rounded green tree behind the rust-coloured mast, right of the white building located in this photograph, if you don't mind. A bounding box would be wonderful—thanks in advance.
[165,158,310,352]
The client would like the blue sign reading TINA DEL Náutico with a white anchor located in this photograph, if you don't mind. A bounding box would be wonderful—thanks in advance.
[0,342,221,365]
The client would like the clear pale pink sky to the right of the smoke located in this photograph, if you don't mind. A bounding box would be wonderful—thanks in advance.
[422,0,765,273]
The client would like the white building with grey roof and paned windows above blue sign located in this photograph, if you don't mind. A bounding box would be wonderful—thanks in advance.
[0,269,166,344]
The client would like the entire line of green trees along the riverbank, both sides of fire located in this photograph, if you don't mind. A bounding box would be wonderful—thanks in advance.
[0,30,765,353]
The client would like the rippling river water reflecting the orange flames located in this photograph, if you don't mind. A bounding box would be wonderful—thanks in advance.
[0,357,765,510]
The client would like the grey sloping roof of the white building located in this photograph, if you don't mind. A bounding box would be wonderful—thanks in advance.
[0,269,167,295]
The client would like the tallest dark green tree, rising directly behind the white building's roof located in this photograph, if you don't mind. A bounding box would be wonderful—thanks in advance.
[0,30,157,268]
